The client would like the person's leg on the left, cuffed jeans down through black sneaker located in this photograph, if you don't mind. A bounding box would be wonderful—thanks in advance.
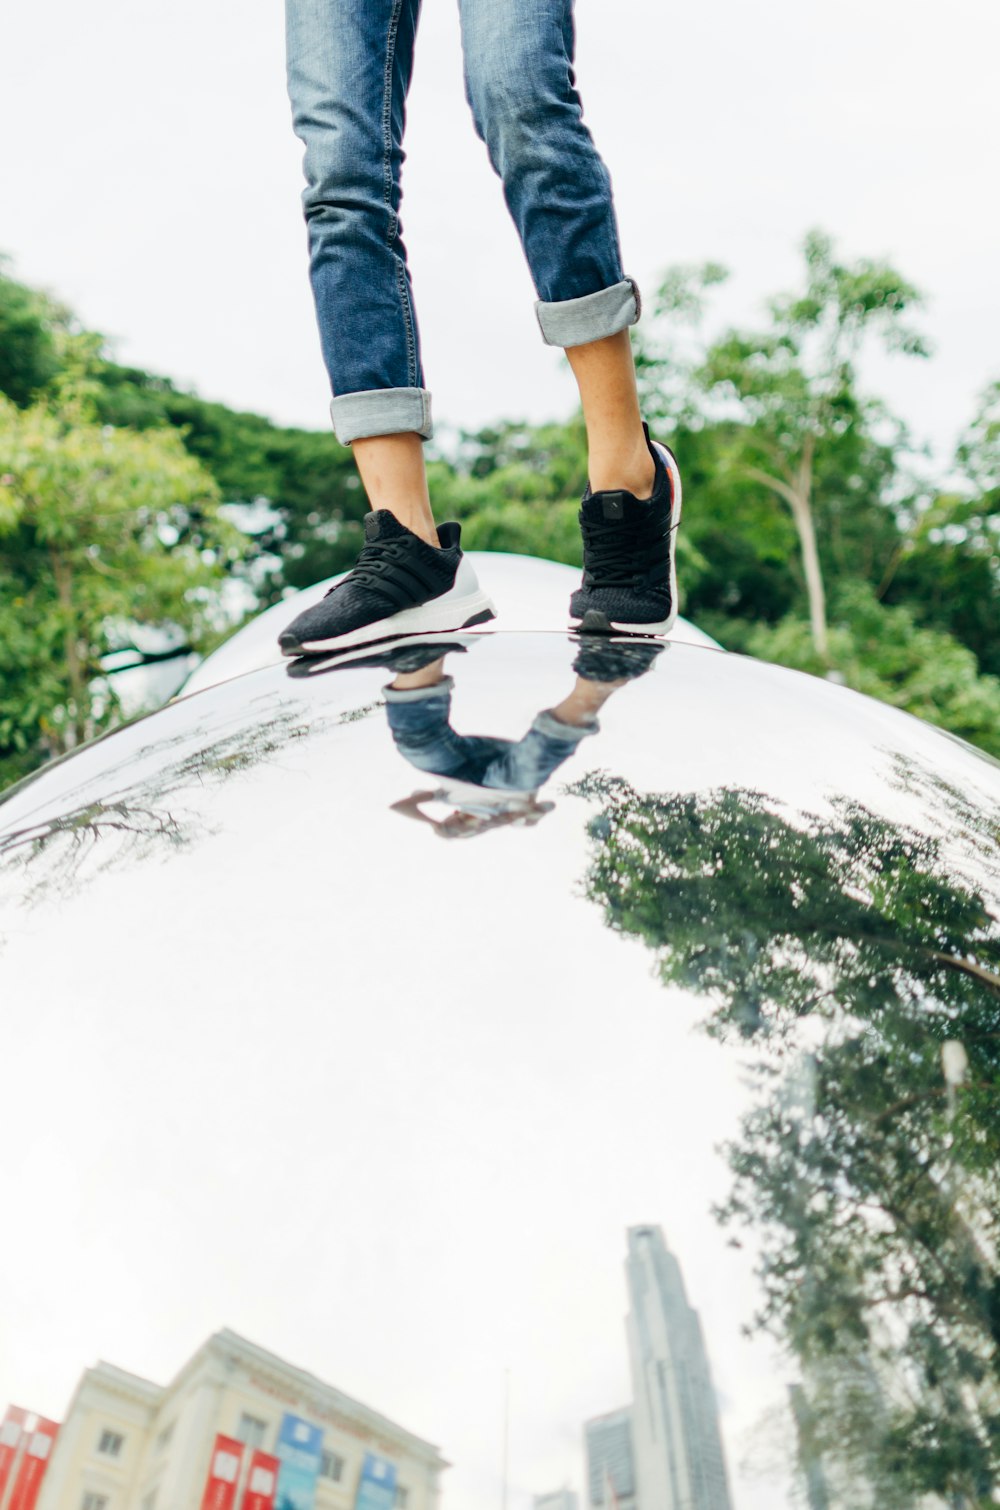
[279,0,492,655]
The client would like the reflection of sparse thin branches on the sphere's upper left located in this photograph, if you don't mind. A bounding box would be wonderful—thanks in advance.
[0,707,308,904]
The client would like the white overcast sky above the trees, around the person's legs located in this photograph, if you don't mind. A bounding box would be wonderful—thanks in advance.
[0,0,1000,465]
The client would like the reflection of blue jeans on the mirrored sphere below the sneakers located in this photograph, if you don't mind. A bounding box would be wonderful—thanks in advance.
[385,676,598,793]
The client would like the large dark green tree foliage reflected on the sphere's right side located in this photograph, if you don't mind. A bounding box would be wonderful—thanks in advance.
[571,769,1000,1507]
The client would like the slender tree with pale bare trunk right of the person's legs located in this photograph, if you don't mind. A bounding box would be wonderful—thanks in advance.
[640,233,926,661]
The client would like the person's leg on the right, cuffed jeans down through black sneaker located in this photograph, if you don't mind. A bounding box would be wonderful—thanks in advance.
[459,0,680,633]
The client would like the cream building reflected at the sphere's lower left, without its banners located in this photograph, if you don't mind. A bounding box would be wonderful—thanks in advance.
[38,1332,447,1510]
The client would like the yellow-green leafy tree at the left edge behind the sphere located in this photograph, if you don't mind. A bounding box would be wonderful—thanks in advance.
[0,396,240,779]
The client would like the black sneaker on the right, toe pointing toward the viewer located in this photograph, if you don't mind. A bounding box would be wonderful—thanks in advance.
[569,424,681,634]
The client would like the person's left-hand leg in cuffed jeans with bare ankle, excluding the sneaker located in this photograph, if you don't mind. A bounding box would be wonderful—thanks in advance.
[285,0,437,545]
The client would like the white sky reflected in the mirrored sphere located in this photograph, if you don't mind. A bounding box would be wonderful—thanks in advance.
[0,636,995,1510]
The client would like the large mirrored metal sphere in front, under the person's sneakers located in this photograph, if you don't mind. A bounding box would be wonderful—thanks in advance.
[0,634,1000,1510]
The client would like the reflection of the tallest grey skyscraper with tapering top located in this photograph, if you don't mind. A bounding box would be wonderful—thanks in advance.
[625,1226,730,1510]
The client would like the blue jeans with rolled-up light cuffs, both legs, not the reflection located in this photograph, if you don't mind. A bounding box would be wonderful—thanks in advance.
[285,0,639,444]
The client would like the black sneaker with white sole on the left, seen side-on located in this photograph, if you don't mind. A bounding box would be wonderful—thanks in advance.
[278,509,495,655]
